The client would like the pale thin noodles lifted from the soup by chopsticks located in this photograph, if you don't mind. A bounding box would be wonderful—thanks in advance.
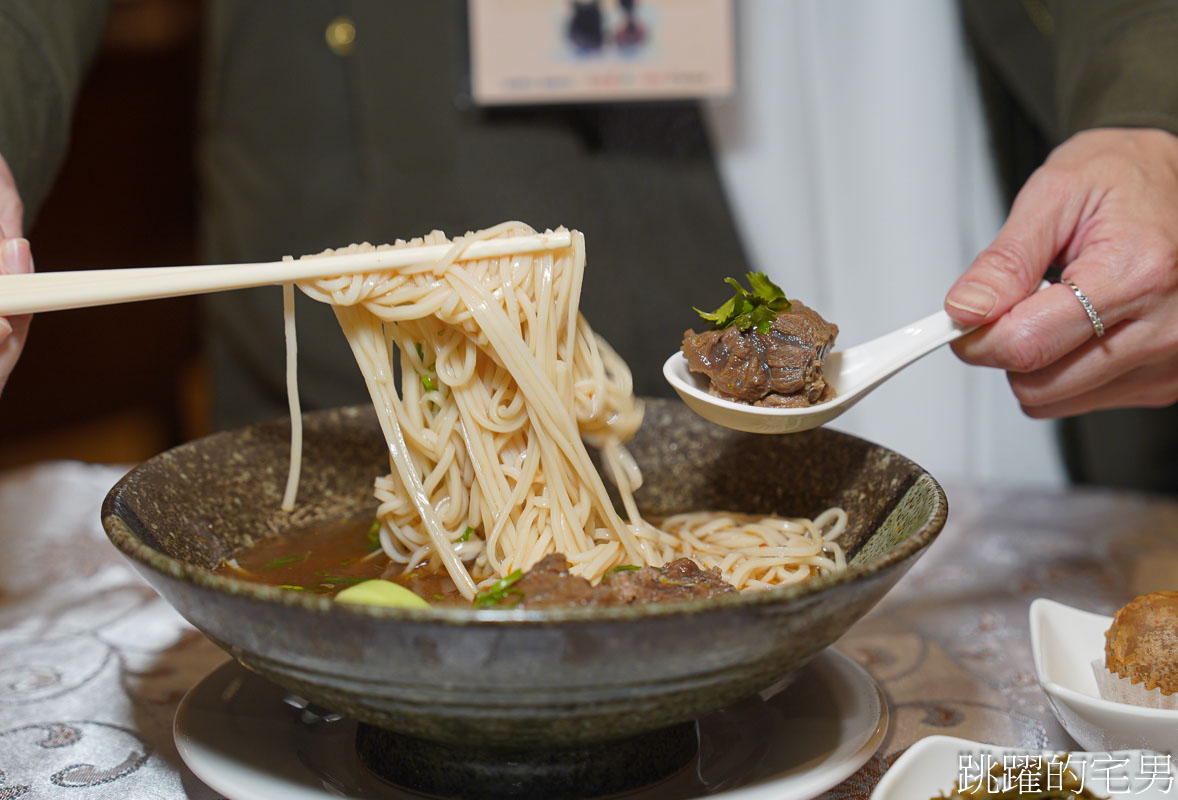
[287,223,846,599]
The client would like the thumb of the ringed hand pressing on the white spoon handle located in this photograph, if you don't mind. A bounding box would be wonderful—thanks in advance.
[945,170,1080,325]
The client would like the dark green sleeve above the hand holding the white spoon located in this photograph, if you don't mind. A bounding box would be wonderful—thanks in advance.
[1055,0,1178,137]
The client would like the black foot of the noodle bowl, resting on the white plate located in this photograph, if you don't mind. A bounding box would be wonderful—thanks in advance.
[356,722,699,800]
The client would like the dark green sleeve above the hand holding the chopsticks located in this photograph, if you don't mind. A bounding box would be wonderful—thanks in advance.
[0,0,110,230]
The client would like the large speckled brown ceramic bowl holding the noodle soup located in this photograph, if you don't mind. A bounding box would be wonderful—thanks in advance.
[102,401,946,747]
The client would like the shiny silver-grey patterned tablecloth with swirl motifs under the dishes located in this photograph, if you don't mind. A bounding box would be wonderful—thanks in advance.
[0,463,1178,800]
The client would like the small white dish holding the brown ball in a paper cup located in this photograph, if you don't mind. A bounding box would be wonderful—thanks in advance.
[1031,597,1178,758]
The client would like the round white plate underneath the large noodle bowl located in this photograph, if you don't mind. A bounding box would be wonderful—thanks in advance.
[174,649,887,800]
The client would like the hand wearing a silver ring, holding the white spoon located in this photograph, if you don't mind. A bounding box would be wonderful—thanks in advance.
[945,128,1178,417]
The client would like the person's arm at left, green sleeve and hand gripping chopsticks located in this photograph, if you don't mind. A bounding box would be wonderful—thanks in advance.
[0,0,110,391]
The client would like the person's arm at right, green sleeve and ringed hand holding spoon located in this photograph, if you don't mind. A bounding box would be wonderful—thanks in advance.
[945,0,1178,417]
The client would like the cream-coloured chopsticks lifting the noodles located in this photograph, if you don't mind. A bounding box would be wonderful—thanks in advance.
[0,231,571,316]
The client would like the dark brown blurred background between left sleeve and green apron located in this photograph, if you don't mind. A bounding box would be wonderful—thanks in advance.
[0,0,210,469]
